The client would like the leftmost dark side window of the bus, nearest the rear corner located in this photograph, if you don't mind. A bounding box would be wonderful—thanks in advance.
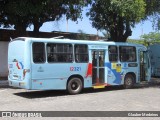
[32,42,45,63]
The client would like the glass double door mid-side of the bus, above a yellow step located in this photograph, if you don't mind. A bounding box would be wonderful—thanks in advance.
[92,50,105,88]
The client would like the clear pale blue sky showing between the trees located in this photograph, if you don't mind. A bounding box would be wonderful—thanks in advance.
[27,8,154,39]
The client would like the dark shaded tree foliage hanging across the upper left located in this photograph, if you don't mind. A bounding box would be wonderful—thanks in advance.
[0,0,90,33]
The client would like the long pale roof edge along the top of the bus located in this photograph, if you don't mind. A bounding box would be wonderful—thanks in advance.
[12,37,144,47]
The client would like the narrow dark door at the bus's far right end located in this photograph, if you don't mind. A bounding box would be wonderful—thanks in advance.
[140,51,151,81]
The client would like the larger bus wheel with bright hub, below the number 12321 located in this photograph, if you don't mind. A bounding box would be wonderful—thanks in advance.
[67,77,83,95]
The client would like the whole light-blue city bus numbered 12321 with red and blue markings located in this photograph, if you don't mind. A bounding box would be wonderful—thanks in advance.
[8,37,151,94]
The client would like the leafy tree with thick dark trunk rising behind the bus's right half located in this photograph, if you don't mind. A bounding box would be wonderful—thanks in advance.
[87,0,146,42]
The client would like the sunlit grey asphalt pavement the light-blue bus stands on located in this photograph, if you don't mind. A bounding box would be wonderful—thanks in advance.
[0,78,160,119]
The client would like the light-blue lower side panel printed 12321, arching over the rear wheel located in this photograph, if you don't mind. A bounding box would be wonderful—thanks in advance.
[32,63,91,90]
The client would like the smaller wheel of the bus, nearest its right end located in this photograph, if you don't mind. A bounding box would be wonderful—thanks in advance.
[124,74,135,89]
